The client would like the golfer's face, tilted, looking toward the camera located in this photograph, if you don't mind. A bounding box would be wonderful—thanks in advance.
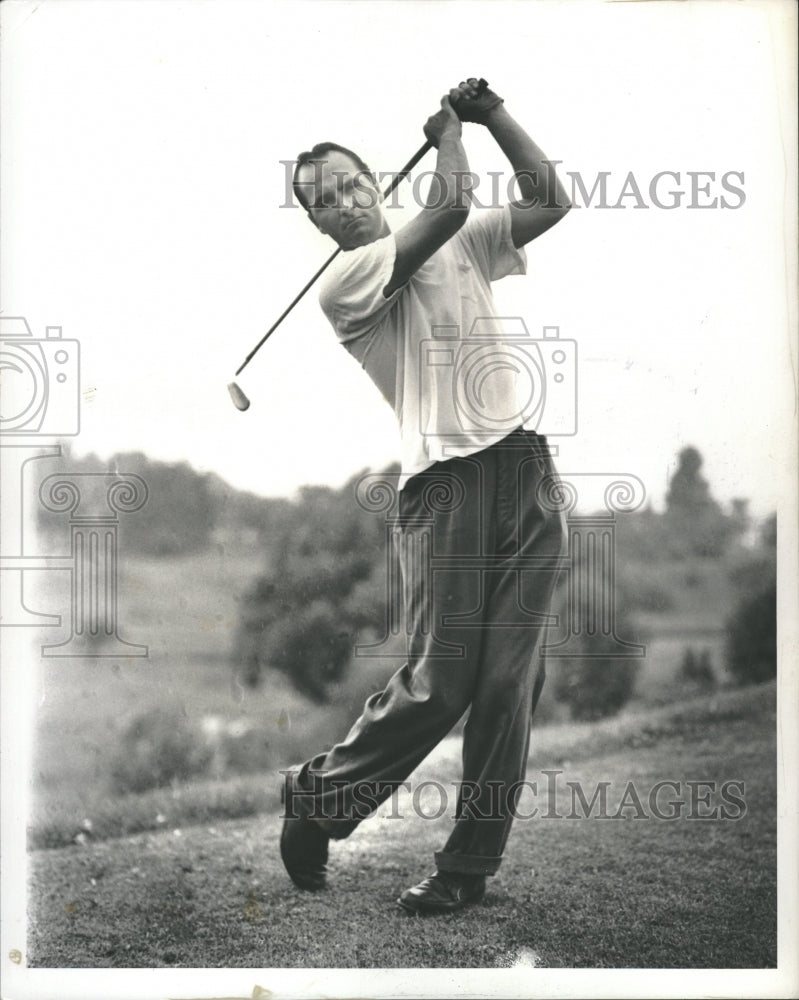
[297,150,389,250]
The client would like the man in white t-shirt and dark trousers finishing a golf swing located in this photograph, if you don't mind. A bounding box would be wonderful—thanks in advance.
[281,79,569,913]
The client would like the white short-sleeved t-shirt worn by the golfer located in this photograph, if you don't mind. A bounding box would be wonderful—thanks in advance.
[319,206,528,489]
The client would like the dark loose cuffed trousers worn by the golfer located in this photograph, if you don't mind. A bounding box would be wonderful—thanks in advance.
[290,431,565,875]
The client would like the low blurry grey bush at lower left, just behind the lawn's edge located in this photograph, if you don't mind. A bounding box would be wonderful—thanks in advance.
[110,708,213,795]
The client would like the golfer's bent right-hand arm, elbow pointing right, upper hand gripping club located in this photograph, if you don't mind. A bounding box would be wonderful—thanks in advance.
[454,78,571,247]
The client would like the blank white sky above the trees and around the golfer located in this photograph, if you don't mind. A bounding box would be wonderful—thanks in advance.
[0,0,796,514]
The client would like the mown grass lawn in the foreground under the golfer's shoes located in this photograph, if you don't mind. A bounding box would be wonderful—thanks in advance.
[27,685,776,969]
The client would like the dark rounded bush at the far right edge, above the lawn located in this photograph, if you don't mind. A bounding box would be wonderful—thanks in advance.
[726,580,777,684]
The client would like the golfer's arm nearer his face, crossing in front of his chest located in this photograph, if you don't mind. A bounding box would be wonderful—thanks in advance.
[383,96,471,297]
